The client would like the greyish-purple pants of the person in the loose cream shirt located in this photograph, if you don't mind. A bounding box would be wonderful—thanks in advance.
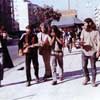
[82,53,96,81]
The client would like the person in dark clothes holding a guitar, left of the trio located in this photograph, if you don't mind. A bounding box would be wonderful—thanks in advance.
[19,25,39,86]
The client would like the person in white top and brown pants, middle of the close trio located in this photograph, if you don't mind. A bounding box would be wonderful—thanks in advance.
[38,23,52,80]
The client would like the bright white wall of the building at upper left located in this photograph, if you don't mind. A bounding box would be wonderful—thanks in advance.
[14,0,29,30]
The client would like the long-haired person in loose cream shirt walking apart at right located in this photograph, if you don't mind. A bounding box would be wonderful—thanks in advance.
[81,18,100,87]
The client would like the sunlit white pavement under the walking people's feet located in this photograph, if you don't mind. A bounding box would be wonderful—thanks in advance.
[0,48,100,100]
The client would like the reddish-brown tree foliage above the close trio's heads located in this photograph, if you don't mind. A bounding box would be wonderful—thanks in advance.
[33,5,61,24]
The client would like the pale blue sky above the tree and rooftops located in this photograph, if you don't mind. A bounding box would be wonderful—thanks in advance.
[30,0,100,19]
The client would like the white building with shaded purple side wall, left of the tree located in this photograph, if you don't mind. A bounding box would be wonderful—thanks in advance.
[13,0,38,31]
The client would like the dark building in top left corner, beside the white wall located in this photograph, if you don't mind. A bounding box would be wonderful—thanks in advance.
[0,0,13,32]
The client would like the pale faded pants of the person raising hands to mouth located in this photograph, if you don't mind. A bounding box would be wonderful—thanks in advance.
[51,55,63,81]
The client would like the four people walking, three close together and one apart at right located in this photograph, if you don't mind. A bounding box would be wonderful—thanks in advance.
[0,18,100,87]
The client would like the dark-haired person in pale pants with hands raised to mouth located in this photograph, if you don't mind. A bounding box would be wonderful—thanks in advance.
[50,25,64,85]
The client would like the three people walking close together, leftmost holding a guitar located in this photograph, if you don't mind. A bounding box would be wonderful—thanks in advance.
[19,23,63,86]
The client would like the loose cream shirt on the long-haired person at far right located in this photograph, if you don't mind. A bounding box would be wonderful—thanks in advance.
[81,30,100,56]
